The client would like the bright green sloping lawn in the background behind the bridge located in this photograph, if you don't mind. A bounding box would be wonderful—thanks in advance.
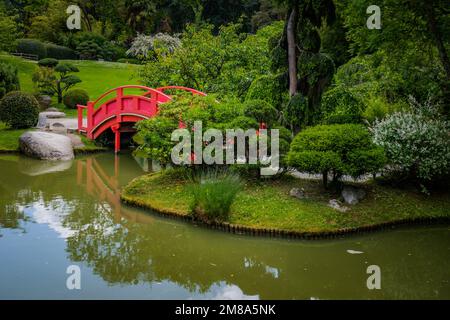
[0,54,140,117]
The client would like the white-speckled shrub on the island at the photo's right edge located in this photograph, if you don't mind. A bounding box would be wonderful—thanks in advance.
[371,99,450,180]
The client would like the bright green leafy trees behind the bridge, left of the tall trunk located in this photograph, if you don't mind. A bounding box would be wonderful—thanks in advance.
[141,23,282,98]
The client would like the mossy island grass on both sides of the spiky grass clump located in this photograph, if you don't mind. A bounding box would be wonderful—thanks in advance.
[122,172,450,232]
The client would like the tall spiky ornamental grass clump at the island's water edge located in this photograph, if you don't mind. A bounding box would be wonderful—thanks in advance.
[190,170,242,222]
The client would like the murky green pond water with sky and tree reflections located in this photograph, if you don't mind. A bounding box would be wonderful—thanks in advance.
[0,154,450,299]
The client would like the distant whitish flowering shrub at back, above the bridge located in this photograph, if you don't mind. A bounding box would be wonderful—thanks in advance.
[127,33,181,60]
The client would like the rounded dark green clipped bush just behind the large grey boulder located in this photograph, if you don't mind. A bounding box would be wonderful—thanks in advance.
[0,91,39,129]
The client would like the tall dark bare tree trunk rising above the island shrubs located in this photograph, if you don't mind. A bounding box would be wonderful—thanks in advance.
[286,7,298,97]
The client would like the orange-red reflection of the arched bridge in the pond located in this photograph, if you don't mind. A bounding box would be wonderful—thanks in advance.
[77,156,153,223]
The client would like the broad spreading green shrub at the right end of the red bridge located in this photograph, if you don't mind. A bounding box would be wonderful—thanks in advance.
[134,96,290,171]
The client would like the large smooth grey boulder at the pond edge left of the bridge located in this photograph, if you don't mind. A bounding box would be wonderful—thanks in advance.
[19,131,74,160]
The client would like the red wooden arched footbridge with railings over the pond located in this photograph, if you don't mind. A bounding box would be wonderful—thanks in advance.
[78,85,206,152]
